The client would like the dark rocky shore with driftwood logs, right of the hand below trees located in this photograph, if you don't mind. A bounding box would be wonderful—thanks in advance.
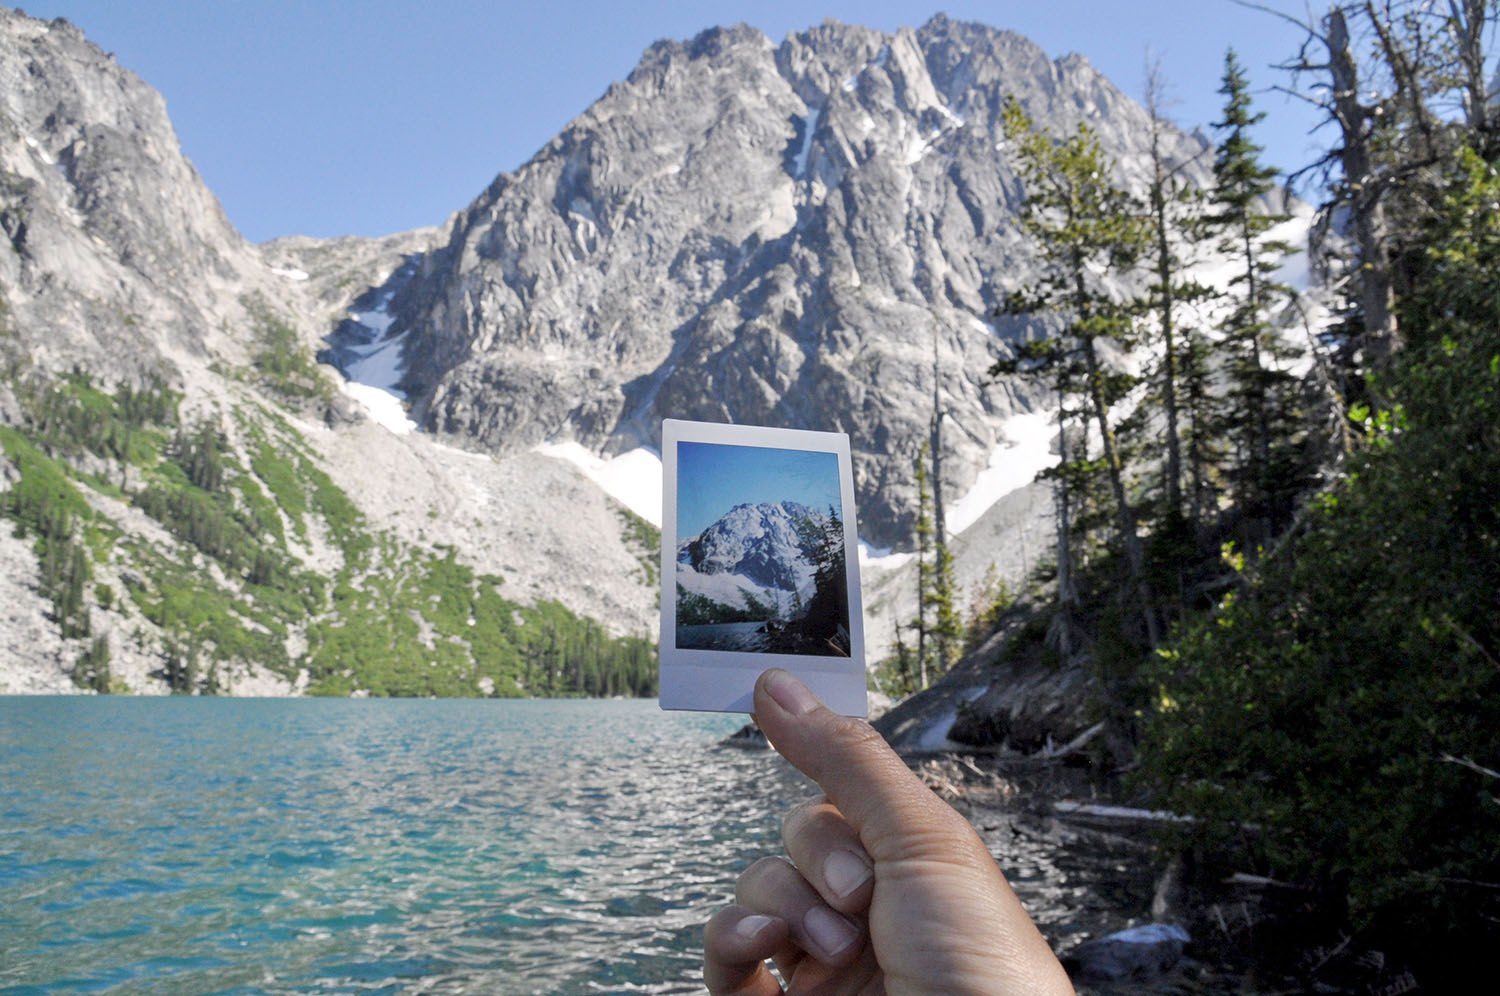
[725,614,1419,995]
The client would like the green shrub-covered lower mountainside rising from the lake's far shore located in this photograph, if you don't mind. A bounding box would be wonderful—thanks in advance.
[0,367,656,696]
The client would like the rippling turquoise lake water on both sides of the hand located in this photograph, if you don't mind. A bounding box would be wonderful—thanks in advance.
[0,698,1149,993]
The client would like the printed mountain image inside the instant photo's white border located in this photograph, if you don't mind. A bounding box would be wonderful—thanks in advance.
[677,441,849,657]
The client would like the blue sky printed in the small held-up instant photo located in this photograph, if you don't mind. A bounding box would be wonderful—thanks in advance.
[677,443,843,542]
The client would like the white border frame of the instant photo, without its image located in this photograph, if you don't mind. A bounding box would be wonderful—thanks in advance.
[660,419,869,717]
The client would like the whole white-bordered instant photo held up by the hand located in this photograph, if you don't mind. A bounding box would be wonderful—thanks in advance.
[662,419,867,716]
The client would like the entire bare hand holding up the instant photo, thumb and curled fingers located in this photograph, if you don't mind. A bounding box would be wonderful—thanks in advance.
[704,669,1073,996]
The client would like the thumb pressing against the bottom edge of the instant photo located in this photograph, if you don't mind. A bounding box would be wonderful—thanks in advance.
[755,668,974,861]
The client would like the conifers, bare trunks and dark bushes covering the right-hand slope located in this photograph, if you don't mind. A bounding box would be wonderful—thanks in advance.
[882,0,1500,984]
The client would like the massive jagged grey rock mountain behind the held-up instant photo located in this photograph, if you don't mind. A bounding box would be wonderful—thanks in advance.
[393,17,1202,545]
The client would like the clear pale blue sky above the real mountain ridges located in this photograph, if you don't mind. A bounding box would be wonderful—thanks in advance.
[23,0,1313,242]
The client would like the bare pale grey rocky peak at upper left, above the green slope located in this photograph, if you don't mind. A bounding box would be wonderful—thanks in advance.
[0,9,276,377]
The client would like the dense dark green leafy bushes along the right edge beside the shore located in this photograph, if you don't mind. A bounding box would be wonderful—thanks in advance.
[1140,147,1500,942]
